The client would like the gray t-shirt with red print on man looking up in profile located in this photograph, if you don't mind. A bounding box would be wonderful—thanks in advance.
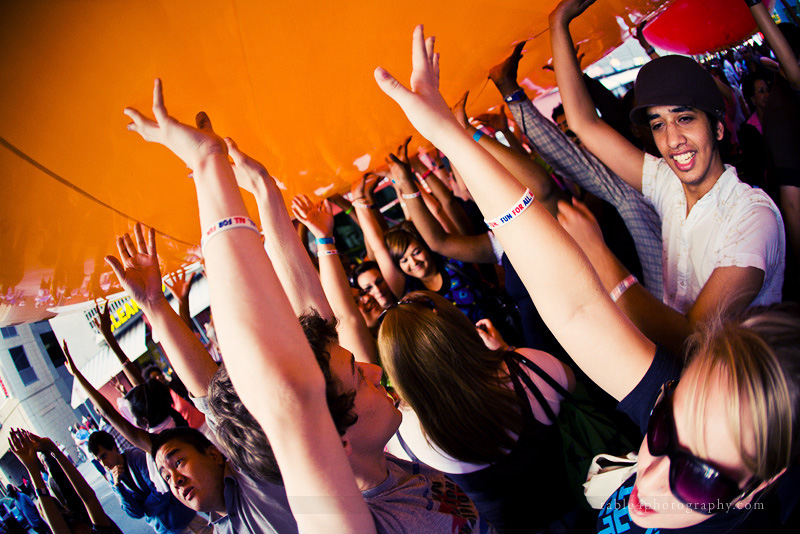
[361,454,496,534]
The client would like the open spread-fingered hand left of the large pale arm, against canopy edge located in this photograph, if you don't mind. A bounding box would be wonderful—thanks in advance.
[105,223,164,306]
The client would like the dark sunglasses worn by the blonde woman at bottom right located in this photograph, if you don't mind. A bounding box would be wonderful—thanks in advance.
[647,381,761,515]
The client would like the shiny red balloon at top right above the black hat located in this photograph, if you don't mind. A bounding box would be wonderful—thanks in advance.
[644,0,775,55]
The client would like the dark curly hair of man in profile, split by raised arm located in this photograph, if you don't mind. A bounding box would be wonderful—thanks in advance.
[208,309,358,483]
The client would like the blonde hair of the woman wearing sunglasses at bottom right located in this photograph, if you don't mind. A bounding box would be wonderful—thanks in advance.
[684,304,800,481]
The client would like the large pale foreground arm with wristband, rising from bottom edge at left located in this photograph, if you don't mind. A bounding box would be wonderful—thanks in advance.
[125,80,375,533]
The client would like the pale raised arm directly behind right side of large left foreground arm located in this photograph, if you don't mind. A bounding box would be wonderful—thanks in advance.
[225,138,333,319]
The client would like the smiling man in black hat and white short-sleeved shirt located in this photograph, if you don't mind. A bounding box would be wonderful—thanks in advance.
[550,0,785,352]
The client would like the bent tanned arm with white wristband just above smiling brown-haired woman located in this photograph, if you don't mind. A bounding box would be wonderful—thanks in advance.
[389,151,497,263]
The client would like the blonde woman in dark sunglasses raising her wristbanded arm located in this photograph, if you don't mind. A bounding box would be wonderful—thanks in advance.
[375,19,800,532]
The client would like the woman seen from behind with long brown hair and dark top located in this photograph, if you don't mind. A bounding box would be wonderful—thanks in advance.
[378,291,576,533]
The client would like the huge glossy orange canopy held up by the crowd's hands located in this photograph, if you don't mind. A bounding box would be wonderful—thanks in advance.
[0,0,676,324]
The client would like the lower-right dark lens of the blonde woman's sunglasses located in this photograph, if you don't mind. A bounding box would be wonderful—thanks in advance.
[669,455,739,514]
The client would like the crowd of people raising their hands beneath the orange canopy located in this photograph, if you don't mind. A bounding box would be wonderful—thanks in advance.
[7,0,800,534]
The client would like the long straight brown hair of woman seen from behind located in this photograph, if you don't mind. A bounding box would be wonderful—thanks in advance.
[378,291,523,463]
